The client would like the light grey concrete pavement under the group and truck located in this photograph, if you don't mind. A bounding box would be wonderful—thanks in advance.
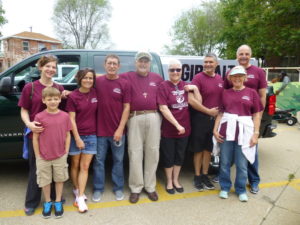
[0,124,300,225]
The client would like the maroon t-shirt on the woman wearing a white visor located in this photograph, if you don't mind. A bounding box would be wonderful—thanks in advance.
[220,87,263,137]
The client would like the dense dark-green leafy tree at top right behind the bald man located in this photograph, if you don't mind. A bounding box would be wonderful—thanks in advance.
[221,0,300,61]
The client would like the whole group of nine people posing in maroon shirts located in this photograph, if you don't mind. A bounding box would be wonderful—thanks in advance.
[19,45,266,218]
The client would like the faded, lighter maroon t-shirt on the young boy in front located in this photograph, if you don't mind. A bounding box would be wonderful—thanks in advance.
[34,110,72,160]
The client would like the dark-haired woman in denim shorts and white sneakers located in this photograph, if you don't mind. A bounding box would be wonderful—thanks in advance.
[66,68,98,213]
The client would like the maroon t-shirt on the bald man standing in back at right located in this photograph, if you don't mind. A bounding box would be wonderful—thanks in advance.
[224,65,268,93]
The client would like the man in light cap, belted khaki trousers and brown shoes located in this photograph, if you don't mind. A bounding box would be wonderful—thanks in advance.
[124,52,163,203]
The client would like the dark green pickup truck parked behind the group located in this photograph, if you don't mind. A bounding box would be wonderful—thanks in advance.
[0,49,163,160]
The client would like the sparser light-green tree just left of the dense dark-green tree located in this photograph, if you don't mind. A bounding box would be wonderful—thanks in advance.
[165,1,223,55]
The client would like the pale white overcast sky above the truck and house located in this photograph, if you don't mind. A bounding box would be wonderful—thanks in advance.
[0,0,201,53]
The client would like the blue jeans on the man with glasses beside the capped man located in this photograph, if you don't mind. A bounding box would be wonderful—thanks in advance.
[93,135,125,192]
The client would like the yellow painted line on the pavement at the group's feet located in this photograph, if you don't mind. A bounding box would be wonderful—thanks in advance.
[0,179,300,218]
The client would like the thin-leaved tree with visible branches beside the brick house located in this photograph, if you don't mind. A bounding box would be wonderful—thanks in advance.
[52,0,110,49]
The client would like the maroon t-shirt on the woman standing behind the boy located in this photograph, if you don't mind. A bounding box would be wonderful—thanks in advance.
[18,80,64,121]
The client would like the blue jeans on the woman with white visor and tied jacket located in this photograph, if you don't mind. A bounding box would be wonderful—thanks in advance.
[219,141,248,195]
